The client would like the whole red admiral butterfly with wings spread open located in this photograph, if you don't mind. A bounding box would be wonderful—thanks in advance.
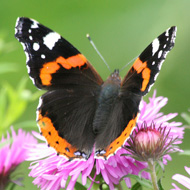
[15,17,177,160]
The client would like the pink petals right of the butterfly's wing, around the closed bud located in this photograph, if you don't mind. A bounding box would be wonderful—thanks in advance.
[138,91,184,164]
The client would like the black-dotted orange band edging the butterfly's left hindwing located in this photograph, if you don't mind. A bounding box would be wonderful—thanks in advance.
[38,114,77,158]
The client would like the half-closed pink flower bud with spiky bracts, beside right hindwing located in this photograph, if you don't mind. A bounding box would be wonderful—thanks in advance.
[125,123,179,162]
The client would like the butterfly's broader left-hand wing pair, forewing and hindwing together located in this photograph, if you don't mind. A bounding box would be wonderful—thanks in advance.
[15,17,103,159]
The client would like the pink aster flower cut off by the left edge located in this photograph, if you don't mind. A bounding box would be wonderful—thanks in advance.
[0,127,37,189]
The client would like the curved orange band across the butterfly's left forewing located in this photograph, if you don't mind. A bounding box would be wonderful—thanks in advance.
[40,54,87,86]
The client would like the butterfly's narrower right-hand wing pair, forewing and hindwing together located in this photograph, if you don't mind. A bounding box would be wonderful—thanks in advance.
[96,27,177,158]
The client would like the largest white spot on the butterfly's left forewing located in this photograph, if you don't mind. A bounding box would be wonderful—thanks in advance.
[43,32,61,50]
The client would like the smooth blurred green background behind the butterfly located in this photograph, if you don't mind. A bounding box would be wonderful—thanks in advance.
[0,0,190,190]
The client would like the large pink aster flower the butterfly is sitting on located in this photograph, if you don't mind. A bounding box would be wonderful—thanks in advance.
[28,93,183,190]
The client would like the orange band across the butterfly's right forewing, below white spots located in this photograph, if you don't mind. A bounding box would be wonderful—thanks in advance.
[133,58,151,92]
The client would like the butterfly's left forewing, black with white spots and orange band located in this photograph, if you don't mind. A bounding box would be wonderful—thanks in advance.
[15,17,103,90]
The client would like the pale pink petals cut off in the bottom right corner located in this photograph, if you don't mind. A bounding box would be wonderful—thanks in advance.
[172,166,190,190]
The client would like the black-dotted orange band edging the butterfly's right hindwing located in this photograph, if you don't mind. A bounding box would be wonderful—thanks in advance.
[101,116,137,157]
